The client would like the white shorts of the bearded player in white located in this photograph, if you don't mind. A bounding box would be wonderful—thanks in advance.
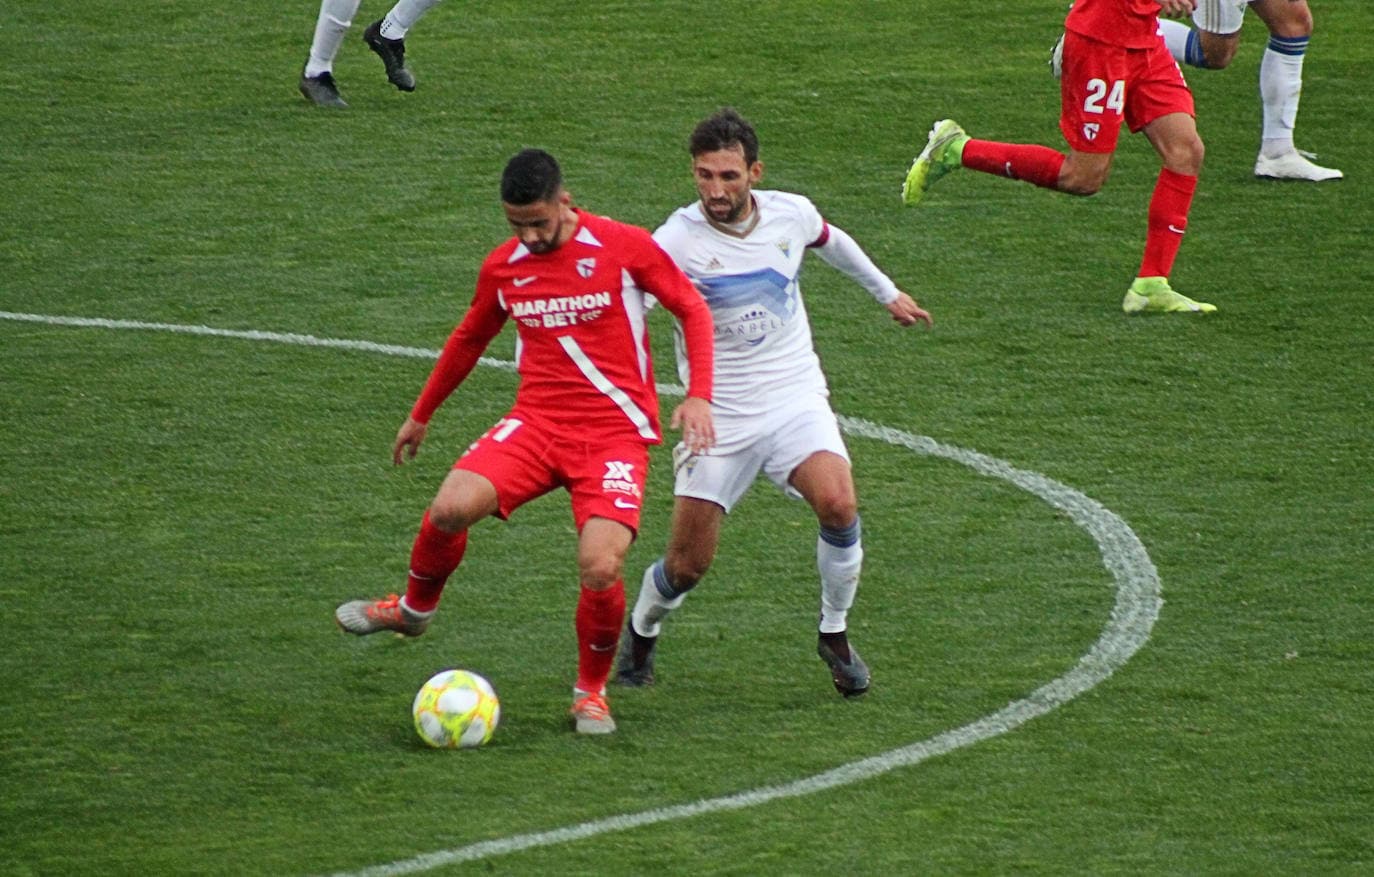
[673,393,849,511]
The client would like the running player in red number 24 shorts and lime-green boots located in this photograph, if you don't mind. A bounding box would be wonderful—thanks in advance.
[901,0,1216,313]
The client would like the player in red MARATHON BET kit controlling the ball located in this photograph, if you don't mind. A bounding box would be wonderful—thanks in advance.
[334,150,714,734]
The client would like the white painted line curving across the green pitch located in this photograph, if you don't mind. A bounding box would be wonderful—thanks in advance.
[0,311,1162,877]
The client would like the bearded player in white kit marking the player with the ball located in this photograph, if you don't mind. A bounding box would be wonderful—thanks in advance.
[616,109,932,697]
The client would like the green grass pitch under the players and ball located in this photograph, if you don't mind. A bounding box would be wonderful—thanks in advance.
[0,0,1374,876]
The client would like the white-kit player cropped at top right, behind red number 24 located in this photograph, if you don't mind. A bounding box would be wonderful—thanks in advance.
[1160,0,1344,183]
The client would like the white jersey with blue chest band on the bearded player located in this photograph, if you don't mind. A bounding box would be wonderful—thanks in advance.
[654,190,829,415]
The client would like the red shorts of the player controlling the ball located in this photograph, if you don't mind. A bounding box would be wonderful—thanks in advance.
[453,412,649,532]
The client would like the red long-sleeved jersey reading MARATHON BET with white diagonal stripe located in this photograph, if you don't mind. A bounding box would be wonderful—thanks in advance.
[411,210,713,444]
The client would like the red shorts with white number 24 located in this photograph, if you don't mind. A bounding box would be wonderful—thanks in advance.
[1059,30,1193,153]
